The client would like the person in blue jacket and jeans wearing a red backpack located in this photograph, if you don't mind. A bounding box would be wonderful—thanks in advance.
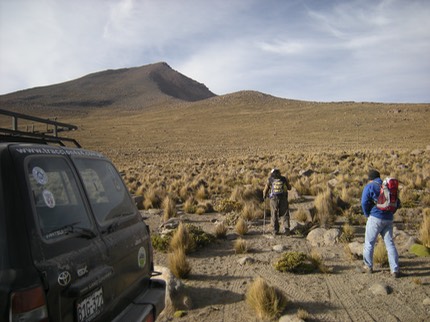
[361,170,400,278]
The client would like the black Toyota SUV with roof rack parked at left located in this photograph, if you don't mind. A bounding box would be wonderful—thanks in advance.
[0,110,166,322]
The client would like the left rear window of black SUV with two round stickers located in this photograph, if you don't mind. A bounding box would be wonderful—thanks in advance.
[27,156,92,239]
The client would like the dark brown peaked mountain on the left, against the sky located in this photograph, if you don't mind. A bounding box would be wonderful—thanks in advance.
[0,63,215,109]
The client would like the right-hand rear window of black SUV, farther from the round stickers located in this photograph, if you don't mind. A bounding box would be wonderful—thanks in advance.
[74,158,136,226]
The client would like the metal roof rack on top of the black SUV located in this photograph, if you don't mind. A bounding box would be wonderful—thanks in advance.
[0,109,81,148]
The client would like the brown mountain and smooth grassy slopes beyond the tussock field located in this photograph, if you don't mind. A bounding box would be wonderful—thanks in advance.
[0,63,430,156]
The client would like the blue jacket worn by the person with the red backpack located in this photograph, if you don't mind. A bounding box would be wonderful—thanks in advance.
[361,178,400,220]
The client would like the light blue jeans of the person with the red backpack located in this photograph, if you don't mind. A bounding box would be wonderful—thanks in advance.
[363,216,399,273]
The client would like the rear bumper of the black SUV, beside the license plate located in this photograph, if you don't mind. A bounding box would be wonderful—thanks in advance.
[112,279,166,322]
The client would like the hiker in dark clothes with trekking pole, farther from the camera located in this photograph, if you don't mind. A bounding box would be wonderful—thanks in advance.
[263,168,291,235]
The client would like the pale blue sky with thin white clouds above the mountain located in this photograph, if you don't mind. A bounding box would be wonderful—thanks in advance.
[0,0,430,103]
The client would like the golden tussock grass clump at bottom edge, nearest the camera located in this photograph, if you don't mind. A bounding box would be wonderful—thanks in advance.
[245,277,287,321]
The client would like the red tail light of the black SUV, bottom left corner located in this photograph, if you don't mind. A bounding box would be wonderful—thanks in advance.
[9,286,49,322]
